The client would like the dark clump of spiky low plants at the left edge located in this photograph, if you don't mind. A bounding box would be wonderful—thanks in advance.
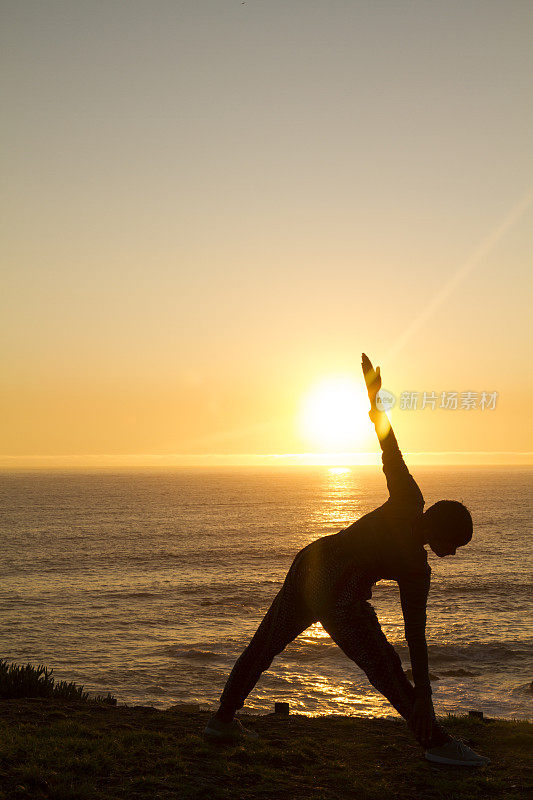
[0,658,117,705]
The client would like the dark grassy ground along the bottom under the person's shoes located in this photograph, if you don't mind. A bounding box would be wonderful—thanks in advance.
[0,698,532,800]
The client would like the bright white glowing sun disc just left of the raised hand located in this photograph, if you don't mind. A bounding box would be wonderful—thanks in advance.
[300,375,369,451]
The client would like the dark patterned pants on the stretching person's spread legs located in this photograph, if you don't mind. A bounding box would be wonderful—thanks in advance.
[220,551,447,746]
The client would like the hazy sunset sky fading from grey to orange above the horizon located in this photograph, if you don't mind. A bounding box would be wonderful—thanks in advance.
[0,0,533,468]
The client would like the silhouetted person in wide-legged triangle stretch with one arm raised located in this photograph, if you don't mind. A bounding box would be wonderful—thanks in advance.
[205,353,488,766]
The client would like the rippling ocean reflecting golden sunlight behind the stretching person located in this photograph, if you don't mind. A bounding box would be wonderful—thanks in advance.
[0,467,533,719]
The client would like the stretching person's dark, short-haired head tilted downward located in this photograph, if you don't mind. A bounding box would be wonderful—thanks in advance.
[417,500,473,557]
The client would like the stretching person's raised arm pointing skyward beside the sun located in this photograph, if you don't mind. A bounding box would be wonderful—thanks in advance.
[361,353,424,507]
